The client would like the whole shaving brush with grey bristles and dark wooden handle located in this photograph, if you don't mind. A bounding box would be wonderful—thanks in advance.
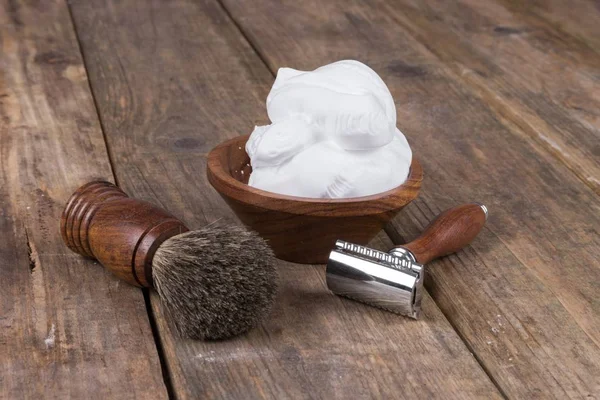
[60,182,277,339]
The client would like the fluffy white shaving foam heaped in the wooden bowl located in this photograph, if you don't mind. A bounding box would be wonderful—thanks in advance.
[246,60,412,199]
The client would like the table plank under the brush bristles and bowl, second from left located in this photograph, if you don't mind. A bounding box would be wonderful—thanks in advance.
[72,1,499,399]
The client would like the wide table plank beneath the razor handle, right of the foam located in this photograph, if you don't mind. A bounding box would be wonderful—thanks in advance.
[217,0,600,398]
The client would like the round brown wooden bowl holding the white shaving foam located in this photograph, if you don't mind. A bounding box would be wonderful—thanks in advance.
[207,135,423,264]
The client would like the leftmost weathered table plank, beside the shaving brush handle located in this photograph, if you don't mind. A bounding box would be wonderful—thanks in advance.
[0,0,167,399]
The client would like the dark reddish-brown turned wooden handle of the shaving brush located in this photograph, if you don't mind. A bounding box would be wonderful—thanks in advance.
[60,181,188,287]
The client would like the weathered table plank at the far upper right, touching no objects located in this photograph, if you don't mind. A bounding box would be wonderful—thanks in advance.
[370,0,600,194]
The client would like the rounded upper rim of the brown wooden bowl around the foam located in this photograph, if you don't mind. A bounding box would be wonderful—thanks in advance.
[207,135,423,216]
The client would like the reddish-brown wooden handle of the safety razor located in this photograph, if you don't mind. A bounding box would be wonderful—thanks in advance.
[398,203,487,264]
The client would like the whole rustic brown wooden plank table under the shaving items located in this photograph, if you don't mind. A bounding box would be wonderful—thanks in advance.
[0,0,600,399]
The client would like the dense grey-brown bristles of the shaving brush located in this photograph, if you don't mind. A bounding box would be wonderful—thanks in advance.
[152,226,277,339]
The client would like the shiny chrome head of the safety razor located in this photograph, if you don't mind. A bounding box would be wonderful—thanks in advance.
[327,240,424,318]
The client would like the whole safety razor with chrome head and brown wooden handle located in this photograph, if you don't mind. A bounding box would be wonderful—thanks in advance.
[327,203,488,319]
